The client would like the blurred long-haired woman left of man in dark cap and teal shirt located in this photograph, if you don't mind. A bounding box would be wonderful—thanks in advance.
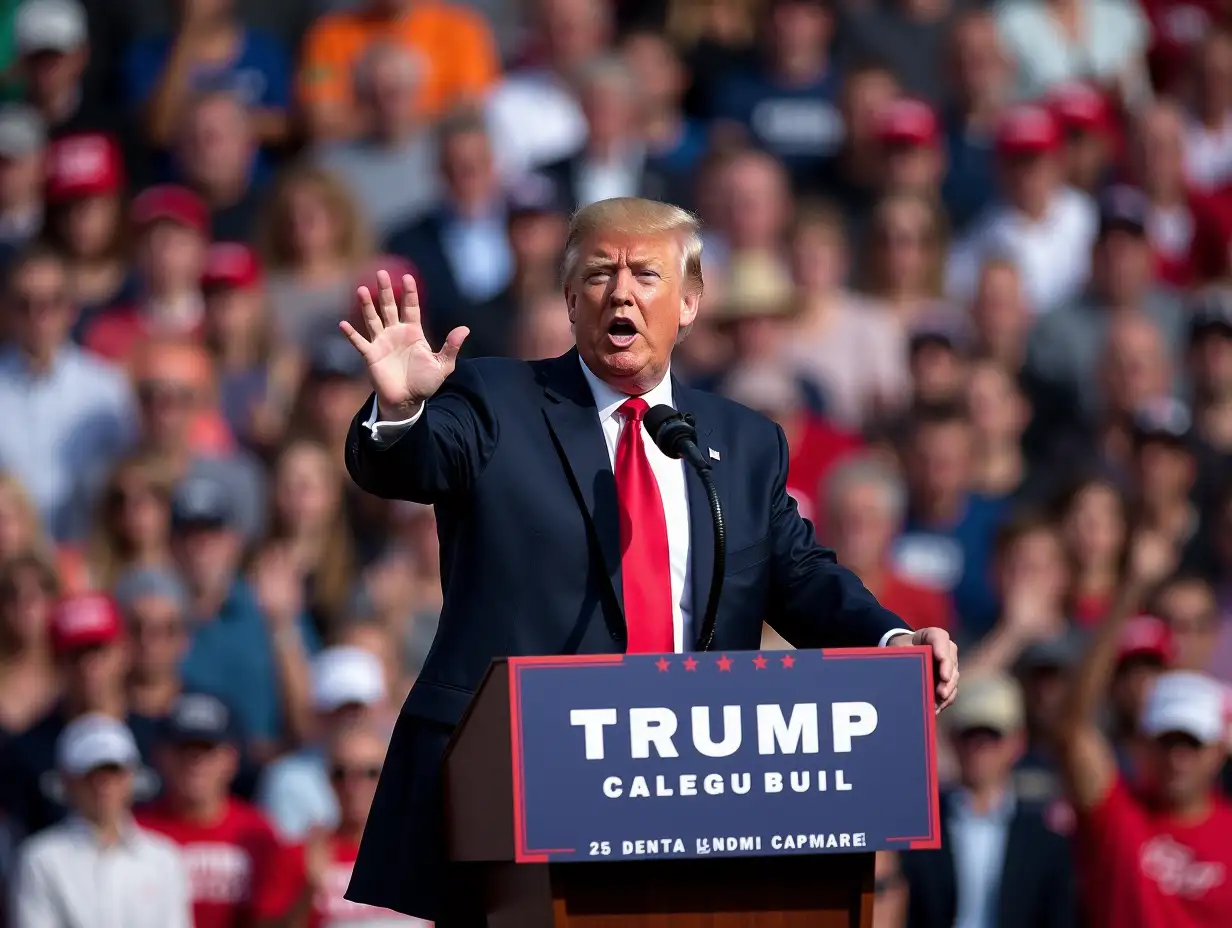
[85,455,175,589]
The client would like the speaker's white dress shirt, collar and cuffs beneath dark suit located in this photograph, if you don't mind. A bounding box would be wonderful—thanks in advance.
[365,357,910,653]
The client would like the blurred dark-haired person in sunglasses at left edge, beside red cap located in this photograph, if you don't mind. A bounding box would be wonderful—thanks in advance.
[0,552,60,739]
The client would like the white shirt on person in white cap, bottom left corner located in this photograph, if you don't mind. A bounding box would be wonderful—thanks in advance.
[12,816,192,928]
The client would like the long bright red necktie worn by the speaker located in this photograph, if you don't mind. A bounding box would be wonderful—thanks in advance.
[616,397,675,654]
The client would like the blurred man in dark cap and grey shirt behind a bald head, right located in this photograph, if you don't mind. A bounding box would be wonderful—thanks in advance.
[1027,186,1185,415]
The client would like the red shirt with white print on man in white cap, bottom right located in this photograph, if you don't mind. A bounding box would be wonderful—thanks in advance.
[1079,778,1232,928]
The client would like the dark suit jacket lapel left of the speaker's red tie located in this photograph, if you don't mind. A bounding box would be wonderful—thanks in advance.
[543,349,625,635]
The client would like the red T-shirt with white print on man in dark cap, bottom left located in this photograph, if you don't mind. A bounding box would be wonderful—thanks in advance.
[137,800,286,928]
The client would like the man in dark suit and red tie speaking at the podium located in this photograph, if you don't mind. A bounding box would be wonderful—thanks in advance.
[342,198,957,926]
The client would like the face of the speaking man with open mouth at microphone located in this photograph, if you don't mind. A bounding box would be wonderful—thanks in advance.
[564,232,700,393]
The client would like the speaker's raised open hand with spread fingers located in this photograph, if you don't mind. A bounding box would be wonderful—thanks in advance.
[340,271,471,419]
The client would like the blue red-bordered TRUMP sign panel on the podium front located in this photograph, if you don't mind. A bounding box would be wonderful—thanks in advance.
[509,647,940,863]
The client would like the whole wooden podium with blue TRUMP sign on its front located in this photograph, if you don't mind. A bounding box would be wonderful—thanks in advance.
[444,648,940,928]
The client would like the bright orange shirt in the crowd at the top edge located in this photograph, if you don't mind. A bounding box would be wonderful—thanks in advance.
[298,0,500,118]
